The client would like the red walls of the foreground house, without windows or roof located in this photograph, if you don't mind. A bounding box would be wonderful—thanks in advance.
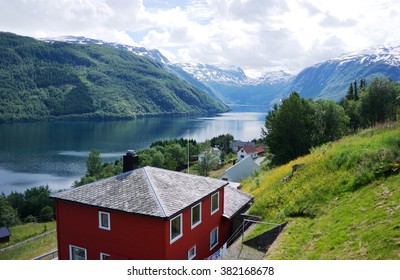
[56,188,231,260]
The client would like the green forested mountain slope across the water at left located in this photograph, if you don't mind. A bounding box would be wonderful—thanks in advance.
[0,32,228,122]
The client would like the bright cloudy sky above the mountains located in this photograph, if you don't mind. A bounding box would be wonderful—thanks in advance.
[0,0,400,76]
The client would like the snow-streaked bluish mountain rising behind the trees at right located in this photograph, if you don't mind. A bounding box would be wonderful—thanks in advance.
[286,45,400,101]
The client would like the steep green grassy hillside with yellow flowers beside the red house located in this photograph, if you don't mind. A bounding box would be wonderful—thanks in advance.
[243,123,400,259]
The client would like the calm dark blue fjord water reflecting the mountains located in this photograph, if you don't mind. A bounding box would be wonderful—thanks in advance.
[0,107,266,194]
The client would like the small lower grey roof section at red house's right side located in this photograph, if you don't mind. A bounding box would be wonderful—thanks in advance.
[224,185,253,218]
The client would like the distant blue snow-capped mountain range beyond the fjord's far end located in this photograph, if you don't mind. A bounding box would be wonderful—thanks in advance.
[41,36,400,106]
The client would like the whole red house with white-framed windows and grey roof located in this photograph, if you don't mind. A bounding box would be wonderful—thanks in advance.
[52,154,252,260]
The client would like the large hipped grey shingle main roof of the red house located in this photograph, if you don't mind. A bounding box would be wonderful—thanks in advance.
[52,167,238,218]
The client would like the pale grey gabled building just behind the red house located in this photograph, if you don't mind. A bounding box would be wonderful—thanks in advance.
[219,156,261,183]
